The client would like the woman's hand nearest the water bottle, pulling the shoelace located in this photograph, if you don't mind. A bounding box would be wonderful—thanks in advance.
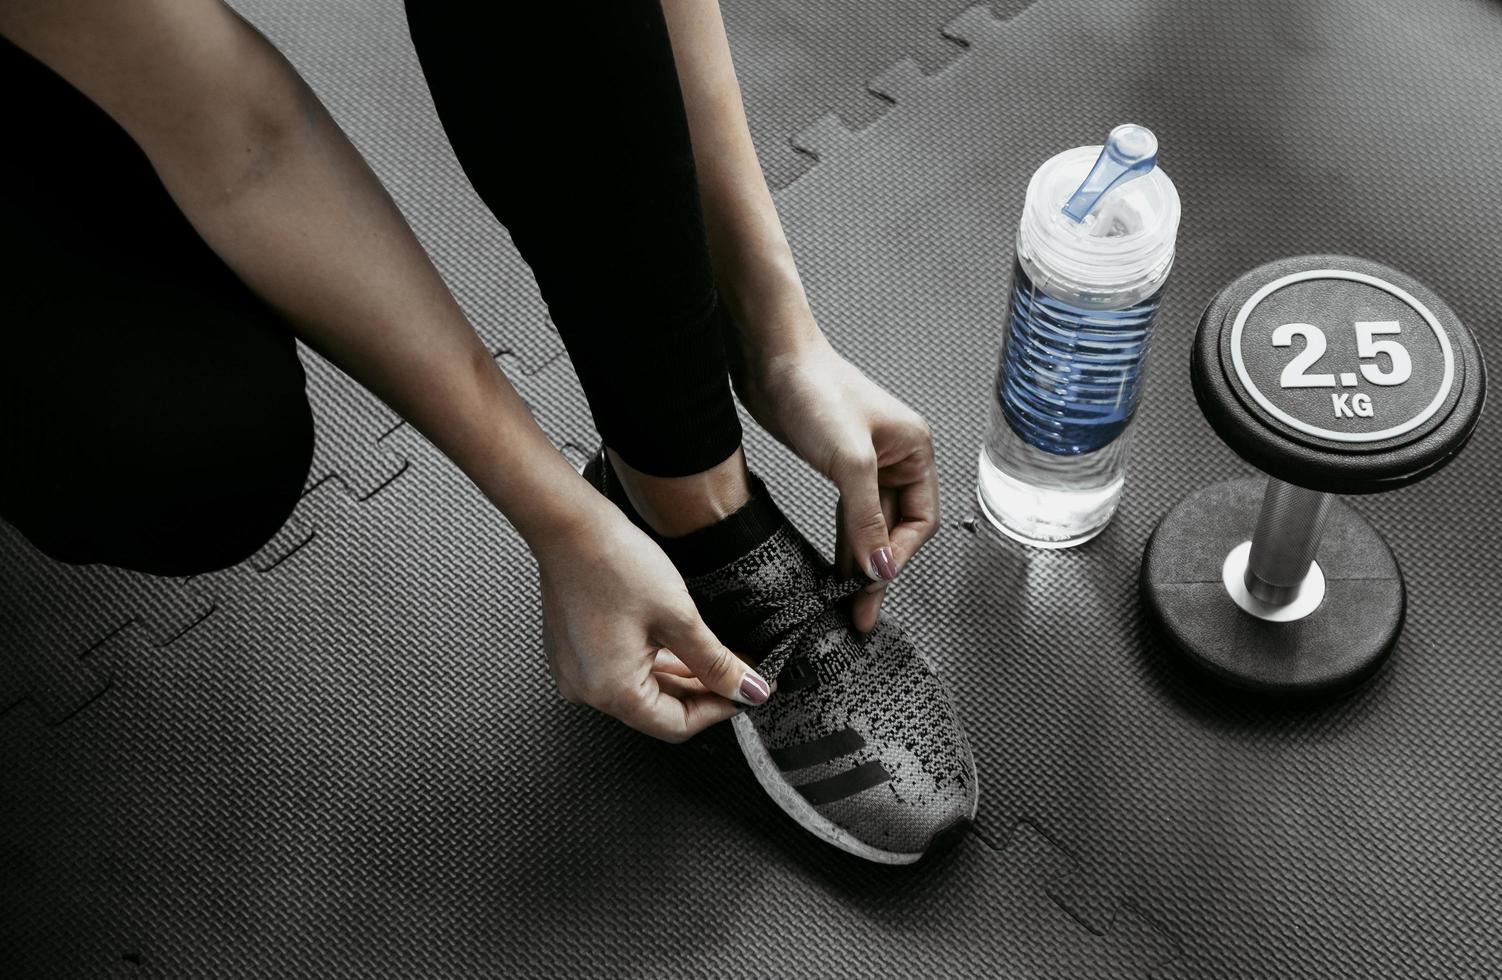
[737,332,939,631]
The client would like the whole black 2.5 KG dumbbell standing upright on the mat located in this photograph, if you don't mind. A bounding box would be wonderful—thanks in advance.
[1142,256,1485,694]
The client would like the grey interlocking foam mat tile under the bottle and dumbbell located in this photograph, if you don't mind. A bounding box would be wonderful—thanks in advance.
[753,0,1502,975]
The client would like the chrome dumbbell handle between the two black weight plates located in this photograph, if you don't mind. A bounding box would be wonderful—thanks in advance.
[1245,476,1331,606]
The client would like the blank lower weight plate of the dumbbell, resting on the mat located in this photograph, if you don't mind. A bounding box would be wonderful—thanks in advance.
[1140,478,1406,697]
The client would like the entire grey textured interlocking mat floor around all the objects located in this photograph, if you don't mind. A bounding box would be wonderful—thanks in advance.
[0,0,1502,978]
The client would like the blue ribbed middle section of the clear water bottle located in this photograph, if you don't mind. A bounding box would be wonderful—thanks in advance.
[997,263,1163,455]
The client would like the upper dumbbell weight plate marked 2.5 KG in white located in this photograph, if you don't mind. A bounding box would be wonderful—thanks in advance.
[1193,256,1485,493]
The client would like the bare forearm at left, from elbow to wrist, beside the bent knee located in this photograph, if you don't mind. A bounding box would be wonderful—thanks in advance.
[174,76,589,538]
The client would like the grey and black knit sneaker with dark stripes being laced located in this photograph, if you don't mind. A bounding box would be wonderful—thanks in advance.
[584,452,978,864]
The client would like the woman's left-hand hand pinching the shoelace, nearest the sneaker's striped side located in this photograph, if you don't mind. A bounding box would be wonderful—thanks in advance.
[533,498,771,743]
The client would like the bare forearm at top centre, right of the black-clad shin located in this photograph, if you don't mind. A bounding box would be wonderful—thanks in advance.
[662,0,823,359]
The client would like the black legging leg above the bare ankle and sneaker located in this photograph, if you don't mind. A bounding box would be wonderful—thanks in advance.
[407,0,740,476]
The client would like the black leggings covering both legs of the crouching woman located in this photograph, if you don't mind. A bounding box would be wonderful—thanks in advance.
[0,0,740,574]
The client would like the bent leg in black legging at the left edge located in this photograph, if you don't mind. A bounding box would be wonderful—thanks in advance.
[0,42,312,574]
